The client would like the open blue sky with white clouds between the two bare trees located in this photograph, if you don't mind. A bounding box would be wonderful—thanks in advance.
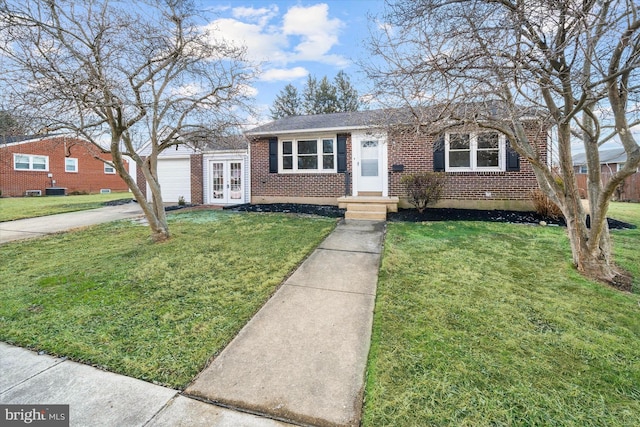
[201,0,384,121]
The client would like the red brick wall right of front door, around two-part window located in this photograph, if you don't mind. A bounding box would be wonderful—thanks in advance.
[388,124,547,200]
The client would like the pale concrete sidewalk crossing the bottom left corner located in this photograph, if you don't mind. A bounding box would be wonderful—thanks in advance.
[0,343,287,427]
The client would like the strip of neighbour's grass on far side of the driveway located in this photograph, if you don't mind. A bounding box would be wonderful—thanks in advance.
[0,192,132,222]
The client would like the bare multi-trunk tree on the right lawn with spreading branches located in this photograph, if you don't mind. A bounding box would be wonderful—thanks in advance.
[366,0,640,287]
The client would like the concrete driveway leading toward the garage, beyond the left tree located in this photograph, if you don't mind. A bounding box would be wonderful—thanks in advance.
[0,202,142,244]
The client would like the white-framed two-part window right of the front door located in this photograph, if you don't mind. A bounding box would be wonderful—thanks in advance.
[445,132,506,172]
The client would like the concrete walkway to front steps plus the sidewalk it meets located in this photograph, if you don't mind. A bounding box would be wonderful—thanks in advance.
[0,221,385,427]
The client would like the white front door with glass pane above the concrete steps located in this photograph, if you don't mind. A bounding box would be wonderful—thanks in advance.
[353,135,386,196]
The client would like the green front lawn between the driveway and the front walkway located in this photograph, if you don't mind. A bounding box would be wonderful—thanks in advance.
[0,211,335,388]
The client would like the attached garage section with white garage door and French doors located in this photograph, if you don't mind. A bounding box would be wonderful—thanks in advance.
[136,135,250,206]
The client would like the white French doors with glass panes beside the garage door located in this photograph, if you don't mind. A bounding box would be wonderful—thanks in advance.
[209,160,244,204]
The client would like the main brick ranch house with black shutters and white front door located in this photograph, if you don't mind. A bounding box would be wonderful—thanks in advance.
[246,110,549,218]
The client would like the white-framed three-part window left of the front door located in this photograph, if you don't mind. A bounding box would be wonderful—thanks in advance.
[278,137,337,173]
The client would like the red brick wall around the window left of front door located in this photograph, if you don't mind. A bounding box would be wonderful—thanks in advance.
[251,135,351,198]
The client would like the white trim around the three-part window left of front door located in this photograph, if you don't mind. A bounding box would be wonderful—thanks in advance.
[278,134,338,174]
